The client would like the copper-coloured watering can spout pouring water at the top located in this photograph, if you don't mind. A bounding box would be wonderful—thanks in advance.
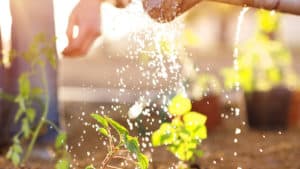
[143,0,300,22]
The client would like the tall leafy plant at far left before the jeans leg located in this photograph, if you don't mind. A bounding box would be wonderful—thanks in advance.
[0,34,69,169]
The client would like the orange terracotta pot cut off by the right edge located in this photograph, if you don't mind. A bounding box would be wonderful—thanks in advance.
[288,91,300,127]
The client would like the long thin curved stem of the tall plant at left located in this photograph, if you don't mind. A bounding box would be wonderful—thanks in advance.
[22,66,49,163]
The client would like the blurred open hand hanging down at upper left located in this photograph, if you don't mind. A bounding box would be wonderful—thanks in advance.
[63,0,101,57]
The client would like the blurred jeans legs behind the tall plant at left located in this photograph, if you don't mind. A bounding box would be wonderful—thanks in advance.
[0,0,59,143]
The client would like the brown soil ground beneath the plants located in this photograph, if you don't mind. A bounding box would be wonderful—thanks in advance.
[0,102,300,169]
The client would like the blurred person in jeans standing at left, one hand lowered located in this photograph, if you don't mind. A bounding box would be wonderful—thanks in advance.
[0,0,129,155]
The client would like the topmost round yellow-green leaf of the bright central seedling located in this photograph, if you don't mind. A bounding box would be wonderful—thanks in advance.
[168,94,192,116]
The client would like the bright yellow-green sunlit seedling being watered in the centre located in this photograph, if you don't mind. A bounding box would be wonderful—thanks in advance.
[152,95,207,167]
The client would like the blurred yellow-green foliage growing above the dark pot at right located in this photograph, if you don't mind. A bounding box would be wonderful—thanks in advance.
[222,11,295,92]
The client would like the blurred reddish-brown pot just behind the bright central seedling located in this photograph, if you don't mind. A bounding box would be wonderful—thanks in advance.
[192,94,221,130]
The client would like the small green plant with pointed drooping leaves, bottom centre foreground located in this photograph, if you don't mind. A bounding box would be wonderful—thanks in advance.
[86,114,149,169]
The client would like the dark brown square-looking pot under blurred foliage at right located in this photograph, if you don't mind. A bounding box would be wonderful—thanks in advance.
[246,87,291,130]
